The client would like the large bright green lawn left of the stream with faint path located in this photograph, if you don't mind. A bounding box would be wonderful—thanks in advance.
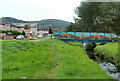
[2,39,111,79]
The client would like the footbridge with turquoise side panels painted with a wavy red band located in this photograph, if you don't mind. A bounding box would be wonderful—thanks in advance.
[55,32,118,43]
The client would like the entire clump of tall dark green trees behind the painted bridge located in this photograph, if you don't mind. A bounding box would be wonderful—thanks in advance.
[72,2,120,34]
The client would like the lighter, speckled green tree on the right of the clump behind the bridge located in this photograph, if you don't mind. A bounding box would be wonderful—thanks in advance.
[97,2,120,34]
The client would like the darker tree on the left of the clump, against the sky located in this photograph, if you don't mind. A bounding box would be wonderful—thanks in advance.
[76,2,101,32]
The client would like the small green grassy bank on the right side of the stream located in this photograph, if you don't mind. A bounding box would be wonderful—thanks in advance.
[95,42,120,70]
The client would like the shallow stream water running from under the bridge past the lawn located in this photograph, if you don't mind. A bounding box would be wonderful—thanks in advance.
[83,43,120,81]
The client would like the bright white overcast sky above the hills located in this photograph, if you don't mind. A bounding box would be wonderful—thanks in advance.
[0,0,82,22]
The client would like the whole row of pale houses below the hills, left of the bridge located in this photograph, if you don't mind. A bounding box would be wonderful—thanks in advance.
[0,20,63,38]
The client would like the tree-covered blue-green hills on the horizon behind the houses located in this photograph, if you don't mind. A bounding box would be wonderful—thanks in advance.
[1,17,71,29]
